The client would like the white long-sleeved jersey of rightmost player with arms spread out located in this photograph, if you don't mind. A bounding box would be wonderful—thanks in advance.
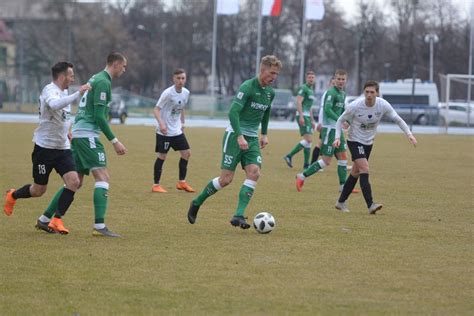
[336,97,411,145]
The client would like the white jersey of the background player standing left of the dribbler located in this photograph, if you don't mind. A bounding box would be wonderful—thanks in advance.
[156,85,189,136]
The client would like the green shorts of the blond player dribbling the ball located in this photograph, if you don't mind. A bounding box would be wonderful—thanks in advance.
[221,131,262,171]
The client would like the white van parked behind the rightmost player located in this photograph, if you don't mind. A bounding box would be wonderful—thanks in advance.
[380,79,439,125]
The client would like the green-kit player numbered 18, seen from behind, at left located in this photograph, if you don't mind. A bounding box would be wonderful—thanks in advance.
[38,53,127,237]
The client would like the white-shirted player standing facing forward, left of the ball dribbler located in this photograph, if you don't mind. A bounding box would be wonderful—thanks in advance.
[151,68,195,193]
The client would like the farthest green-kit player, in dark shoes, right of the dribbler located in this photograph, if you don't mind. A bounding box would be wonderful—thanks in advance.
[283,70,316,169]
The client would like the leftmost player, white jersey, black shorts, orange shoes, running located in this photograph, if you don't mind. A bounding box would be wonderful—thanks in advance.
[3,62,90,234]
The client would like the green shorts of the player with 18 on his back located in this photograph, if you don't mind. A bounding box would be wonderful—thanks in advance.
[71,137,107,175]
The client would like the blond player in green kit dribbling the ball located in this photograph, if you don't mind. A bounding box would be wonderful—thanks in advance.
[188,55,282,229]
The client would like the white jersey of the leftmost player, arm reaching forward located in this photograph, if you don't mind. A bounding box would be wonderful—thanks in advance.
[33,82,79,149]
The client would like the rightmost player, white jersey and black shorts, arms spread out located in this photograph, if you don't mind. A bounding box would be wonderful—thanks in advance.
[333,80,417,214]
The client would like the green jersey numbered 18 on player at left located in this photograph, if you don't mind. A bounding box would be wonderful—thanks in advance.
[72,70,115,140]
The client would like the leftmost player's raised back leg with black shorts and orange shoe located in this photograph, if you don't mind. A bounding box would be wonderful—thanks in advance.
[3,145,53,216]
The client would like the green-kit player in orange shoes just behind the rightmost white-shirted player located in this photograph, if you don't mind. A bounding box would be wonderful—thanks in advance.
[296,69,347,192]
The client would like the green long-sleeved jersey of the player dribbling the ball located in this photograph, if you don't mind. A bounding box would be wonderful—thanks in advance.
[227,77,275,137]
